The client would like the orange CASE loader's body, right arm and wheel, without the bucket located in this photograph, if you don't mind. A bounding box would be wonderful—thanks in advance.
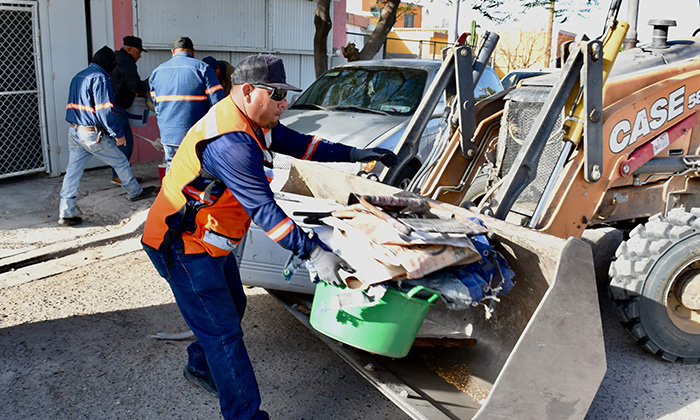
[412,2,700,363]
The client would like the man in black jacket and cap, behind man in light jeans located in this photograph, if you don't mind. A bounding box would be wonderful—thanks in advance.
[110,35,148,185]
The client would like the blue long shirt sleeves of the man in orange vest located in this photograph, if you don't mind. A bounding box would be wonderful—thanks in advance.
[201,124,352,259]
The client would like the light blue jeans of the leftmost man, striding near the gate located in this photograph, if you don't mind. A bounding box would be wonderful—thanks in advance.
[58,127,143,218]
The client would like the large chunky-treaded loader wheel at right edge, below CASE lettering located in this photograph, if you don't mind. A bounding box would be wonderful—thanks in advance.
[609,209,700,363]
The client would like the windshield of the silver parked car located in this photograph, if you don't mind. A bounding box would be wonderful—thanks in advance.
[292,67,428,115]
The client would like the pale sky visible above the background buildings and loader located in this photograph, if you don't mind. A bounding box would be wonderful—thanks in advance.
[347,0,700,43]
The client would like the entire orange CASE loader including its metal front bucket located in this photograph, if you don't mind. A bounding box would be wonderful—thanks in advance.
[249,0,700,419]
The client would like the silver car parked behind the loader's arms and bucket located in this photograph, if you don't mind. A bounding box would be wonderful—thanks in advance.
[275,59,503,188]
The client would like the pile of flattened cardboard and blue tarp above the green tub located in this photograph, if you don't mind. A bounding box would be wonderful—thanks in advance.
[294,195,513,310]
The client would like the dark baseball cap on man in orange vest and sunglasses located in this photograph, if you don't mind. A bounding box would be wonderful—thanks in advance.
[231,54,301,92]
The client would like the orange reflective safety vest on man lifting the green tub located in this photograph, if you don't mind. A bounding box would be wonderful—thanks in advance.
[142,96,272,257]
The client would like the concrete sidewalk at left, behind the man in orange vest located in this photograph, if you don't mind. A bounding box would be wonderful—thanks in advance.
[0,162,160,278]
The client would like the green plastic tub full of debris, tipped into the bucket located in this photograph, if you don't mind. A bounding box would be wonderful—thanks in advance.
[310,283,440,357]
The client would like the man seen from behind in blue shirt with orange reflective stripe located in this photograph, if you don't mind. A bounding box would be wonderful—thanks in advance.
[149,36,225,169]
